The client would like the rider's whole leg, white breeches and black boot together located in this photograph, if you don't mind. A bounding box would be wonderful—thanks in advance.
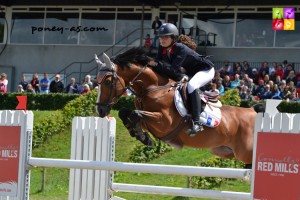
[187,68,215,136]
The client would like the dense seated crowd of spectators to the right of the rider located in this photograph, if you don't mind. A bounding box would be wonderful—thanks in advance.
[212,60,300,101]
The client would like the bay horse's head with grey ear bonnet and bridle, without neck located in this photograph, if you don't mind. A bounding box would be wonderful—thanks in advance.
[95,53,126,117]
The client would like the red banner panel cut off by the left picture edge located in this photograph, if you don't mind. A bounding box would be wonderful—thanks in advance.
[0,126,21,196]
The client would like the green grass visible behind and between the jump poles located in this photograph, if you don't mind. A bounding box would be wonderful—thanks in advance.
[30,111,250,200]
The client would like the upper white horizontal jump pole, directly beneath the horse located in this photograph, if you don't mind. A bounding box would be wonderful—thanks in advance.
[28,157,251,181]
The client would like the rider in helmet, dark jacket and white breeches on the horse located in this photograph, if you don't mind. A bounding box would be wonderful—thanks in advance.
[148,23,215,136]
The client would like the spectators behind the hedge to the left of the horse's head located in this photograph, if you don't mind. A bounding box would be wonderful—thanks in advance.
[0,73,95,94]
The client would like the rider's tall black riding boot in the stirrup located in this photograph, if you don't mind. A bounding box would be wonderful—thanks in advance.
[188,90,203,136]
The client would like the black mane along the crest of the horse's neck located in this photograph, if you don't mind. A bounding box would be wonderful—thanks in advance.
[113,47,150,68]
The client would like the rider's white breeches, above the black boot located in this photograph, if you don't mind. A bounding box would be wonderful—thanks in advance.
[188,67,215,94]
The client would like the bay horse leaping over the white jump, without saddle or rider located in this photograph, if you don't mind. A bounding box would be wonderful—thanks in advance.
[95,47,257,165]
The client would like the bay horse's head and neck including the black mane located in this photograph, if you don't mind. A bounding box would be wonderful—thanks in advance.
[95,47,162,117]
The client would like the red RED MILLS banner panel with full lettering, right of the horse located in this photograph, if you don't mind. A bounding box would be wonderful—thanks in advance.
[253,132,300,200]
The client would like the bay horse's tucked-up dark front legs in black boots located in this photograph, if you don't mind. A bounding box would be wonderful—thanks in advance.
[119,108,154,146]
